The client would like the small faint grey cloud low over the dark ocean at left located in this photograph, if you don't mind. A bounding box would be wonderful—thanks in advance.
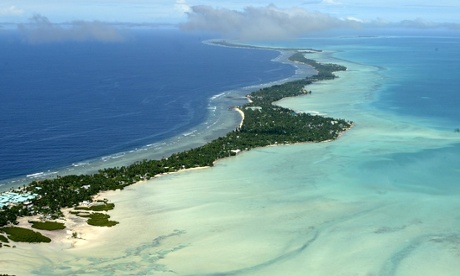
[18,15,124,43]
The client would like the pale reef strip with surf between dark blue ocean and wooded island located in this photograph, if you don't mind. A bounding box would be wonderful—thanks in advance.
[0,47,313,193]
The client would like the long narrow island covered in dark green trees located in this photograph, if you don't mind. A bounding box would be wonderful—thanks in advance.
[0,50,352,247]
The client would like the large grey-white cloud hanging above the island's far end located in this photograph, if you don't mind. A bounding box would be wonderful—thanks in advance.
[181,5,360,40]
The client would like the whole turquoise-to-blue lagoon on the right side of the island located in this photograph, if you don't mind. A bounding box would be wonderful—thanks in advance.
[0,31,460,275]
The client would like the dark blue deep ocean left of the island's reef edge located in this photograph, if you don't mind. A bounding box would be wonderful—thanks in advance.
[0,30,294,180]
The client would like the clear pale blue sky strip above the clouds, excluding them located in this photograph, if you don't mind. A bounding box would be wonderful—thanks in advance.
[0,0,460,23]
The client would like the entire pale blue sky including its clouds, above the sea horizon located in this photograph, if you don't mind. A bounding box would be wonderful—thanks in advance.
[0,0,460,40]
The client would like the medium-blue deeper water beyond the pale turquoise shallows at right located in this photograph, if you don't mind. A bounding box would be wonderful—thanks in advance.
[257,33,460,128]
